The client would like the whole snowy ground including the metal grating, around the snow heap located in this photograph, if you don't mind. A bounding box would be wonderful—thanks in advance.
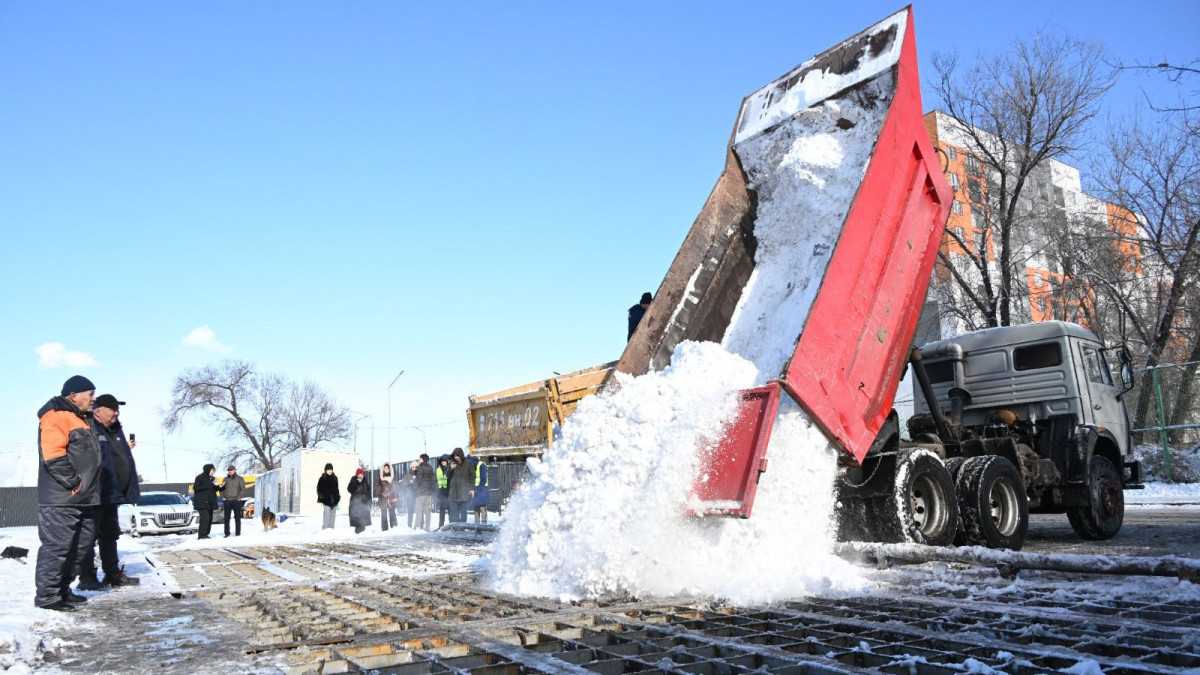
[0,485,1200,673]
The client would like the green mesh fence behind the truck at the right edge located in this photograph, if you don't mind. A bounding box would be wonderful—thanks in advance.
[1127,362,1200,480]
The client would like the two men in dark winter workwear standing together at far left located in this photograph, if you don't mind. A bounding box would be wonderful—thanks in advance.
[34,375,142,611]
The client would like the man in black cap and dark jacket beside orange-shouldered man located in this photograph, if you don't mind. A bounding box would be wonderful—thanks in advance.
[79,394,142,591]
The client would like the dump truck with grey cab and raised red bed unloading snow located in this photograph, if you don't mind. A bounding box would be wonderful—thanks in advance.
[476,7,1140,549]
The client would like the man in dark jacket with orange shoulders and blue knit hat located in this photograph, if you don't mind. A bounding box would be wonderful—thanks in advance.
[34,375,101,611]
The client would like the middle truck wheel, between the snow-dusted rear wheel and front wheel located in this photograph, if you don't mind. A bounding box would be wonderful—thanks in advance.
[958,455,1030,551]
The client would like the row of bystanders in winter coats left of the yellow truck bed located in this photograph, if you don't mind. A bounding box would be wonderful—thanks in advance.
[317,448,490,533]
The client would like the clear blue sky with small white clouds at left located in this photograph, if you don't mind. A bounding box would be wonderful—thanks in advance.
[0,0,1200,480]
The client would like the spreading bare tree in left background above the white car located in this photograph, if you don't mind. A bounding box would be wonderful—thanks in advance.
[163,360,349,471]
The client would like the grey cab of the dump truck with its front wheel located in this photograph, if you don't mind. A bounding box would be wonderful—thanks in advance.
[908,321,1141,538]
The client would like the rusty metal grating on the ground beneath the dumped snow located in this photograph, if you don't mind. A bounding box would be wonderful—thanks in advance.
[145,539,1200,675]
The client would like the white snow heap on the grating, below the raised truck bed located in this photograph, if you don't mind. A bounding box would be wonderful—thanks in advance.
[492,342,860,602]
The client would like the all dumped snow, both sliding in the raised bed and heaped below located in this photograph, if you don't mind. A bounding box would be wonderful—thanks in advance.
[492,76,892,602]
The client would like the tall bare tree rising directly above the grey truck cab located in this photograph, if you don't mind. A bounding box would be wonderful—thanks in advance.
[934,34,1115,327]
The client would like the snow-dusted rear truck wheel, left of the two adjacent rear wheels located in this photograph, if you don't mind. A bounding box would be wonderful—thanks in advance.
[875,448,959,546]
